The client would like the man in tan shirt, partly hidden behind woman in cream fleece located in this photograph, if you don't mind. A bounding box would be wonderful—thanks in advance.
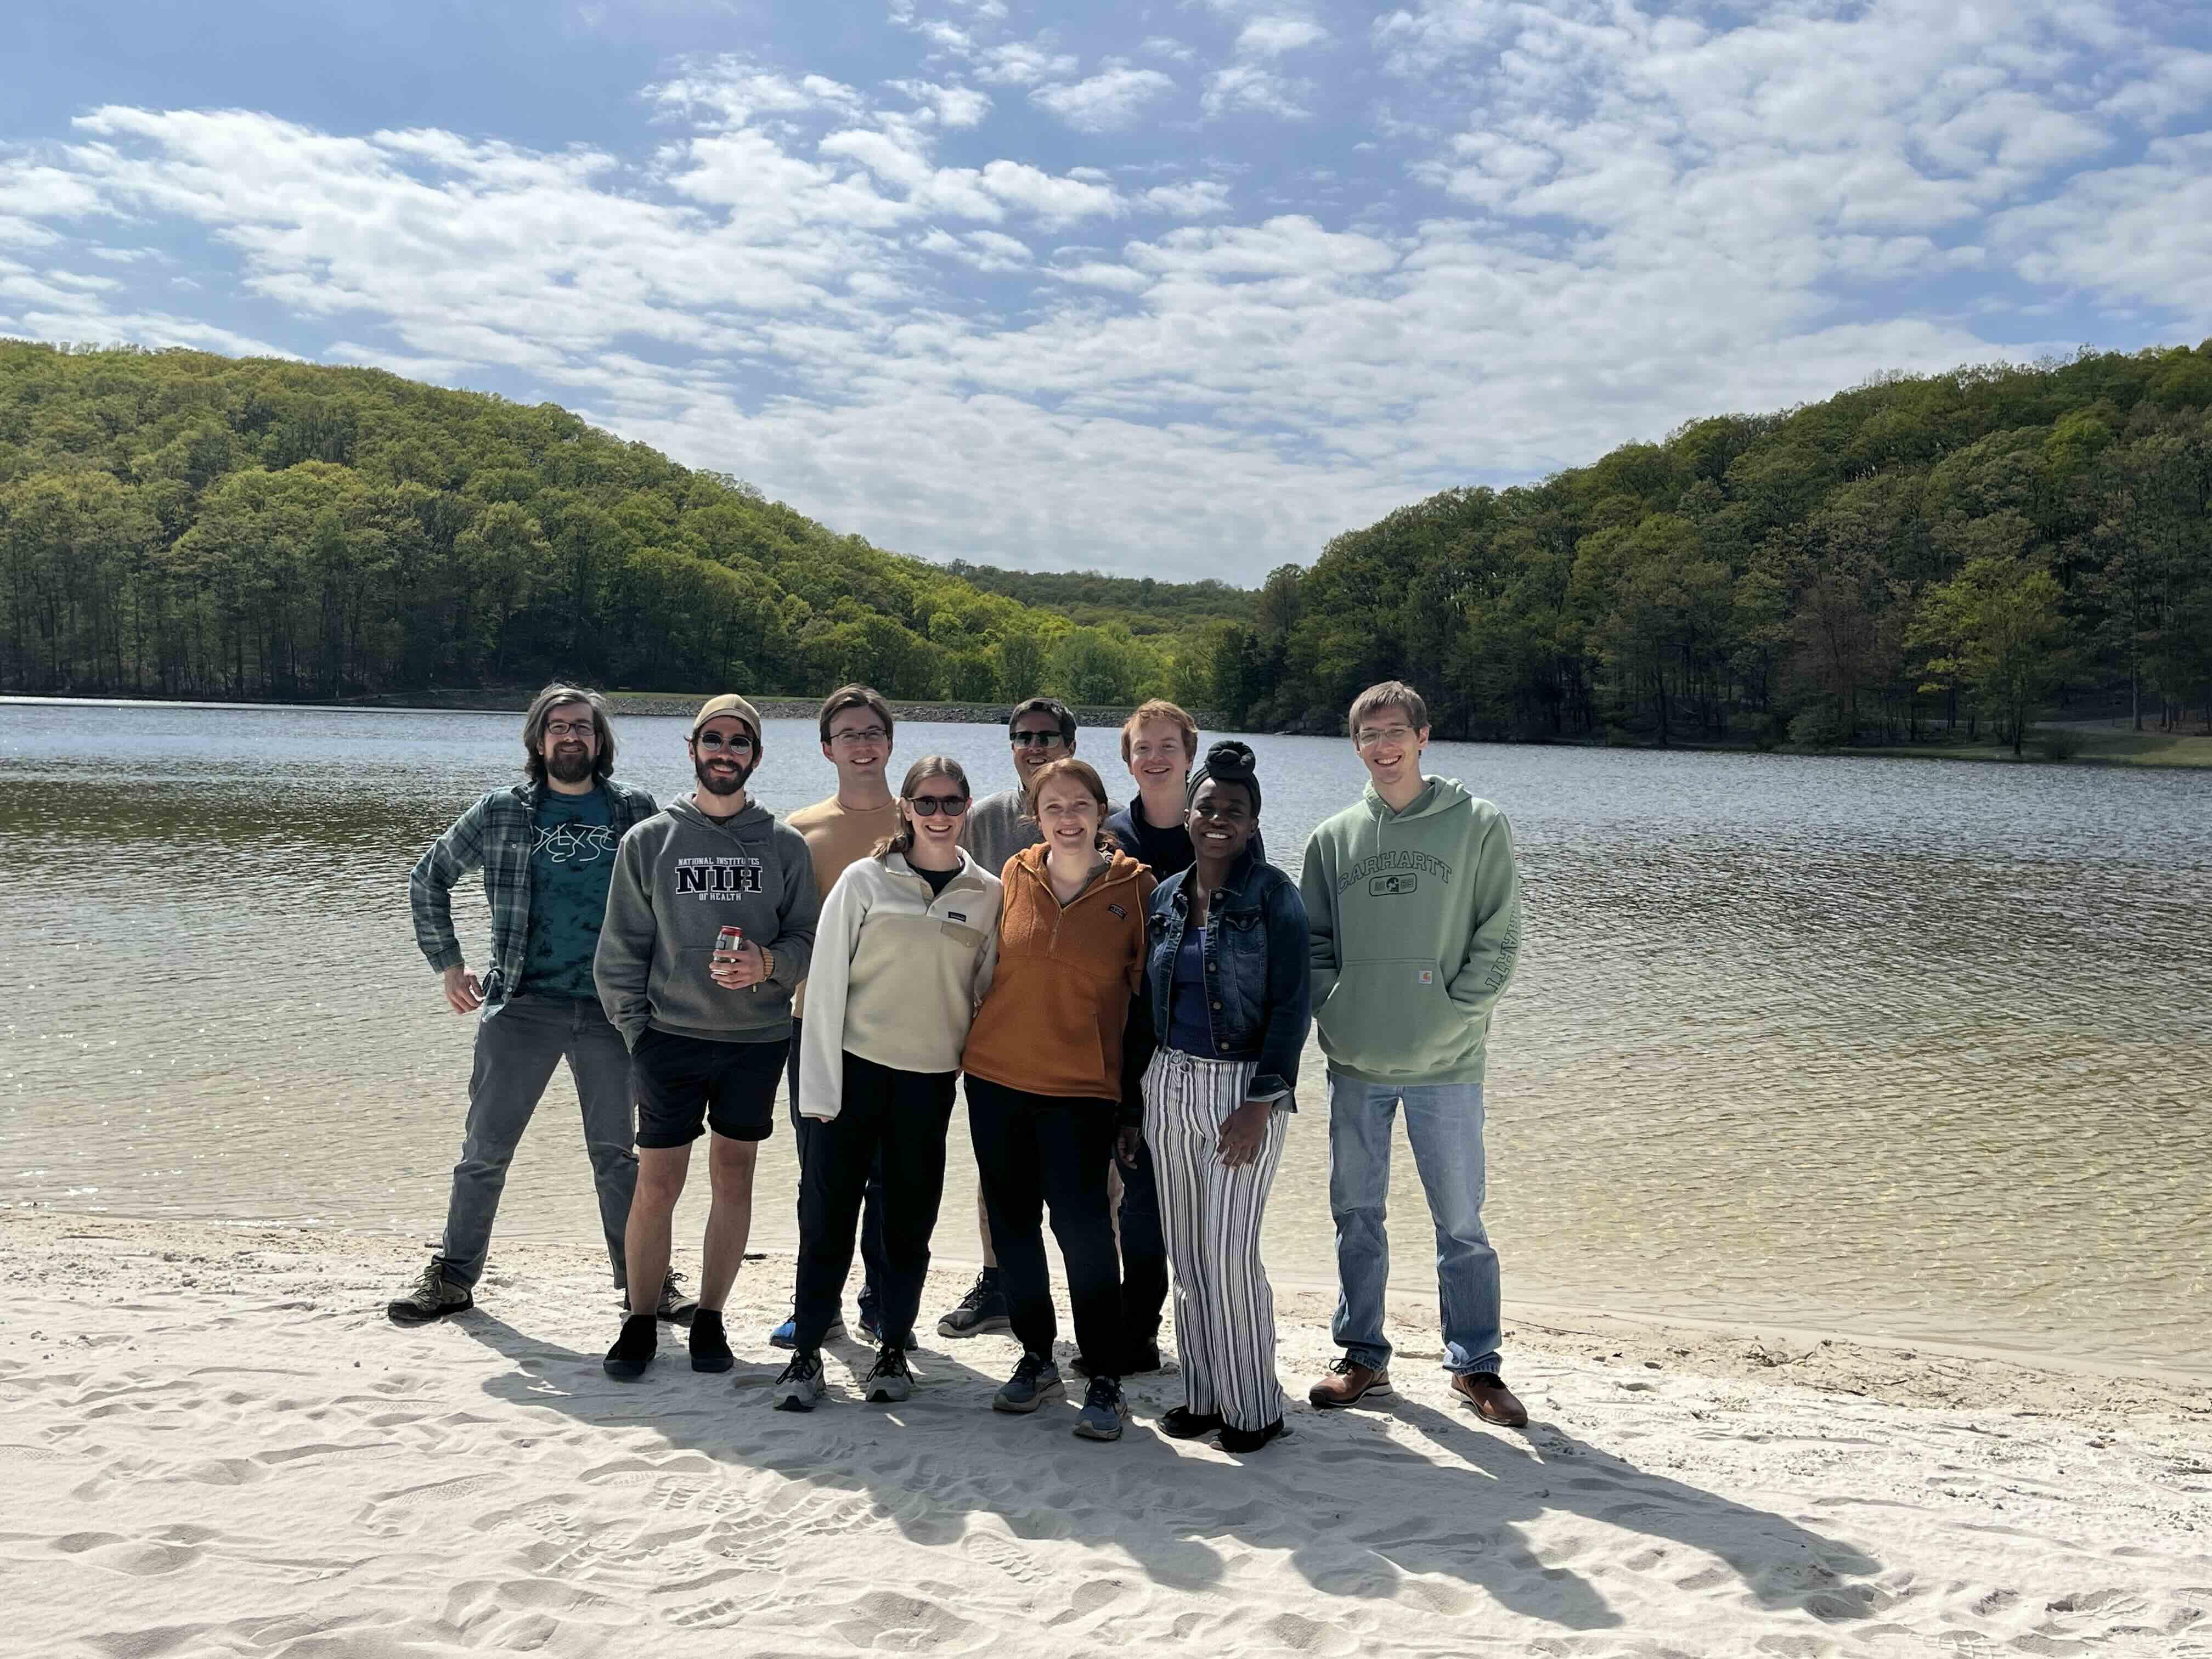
[768,686,893,1347]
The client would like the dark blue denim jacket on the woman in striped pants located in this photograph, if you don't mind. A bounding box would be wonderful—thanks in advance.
[1146,849,1314,1099]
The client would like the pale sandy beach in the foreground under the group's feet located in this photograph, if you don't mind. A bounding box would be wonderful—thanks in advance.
[0,1215,2212,1659]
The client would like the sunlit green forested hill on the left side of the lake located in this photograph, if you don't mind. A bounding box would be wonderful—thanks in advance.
[0,341,1212,708]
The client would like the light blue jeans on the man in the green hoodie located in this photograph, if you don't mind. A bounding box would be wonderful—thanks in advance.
[1329,1070,1502,1376]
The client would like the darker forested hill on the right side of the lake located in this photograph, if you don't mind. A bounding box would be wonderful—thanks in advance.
[1212,343,2212,743]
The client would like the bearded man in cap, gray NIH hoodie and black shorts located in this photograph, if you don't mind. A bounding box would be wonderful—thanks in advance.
[593,692,821,1378]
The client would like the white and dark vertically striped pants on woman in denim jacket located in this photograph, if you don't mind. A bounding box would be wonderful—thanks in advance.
[1144,1048,1290,1429]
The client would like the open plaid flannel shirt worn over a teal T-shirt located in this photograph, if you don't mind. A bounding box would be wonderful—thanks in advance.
[407,778,659,1018]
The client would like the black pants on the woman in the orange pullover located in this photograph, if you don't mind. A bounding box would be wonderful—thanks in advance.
[969,1077,1128,1376]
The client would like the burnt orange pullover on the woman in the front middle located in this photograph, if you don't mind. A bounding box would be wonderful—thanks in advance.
[960,847,1155,1102]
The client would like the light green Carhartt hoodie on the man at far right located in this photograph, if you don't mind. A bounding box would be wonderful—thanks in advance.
[1299,778,1520,1084]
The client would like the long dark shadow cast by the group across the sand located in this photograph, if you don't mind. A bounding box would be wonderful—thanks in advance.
[454,1312,1880,1630]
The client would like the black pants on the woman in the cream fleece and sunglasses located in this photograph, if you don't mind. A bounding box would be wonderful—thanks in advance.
[797,1053,958,1354]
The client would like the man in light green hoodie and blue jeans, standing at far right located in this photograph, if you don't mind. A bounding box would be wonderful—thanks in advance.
[1299,679,1528,1429]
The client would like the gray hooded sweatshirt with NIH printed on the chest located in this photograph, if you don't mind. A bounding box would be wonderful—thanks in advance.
[591,797,821,1048]
